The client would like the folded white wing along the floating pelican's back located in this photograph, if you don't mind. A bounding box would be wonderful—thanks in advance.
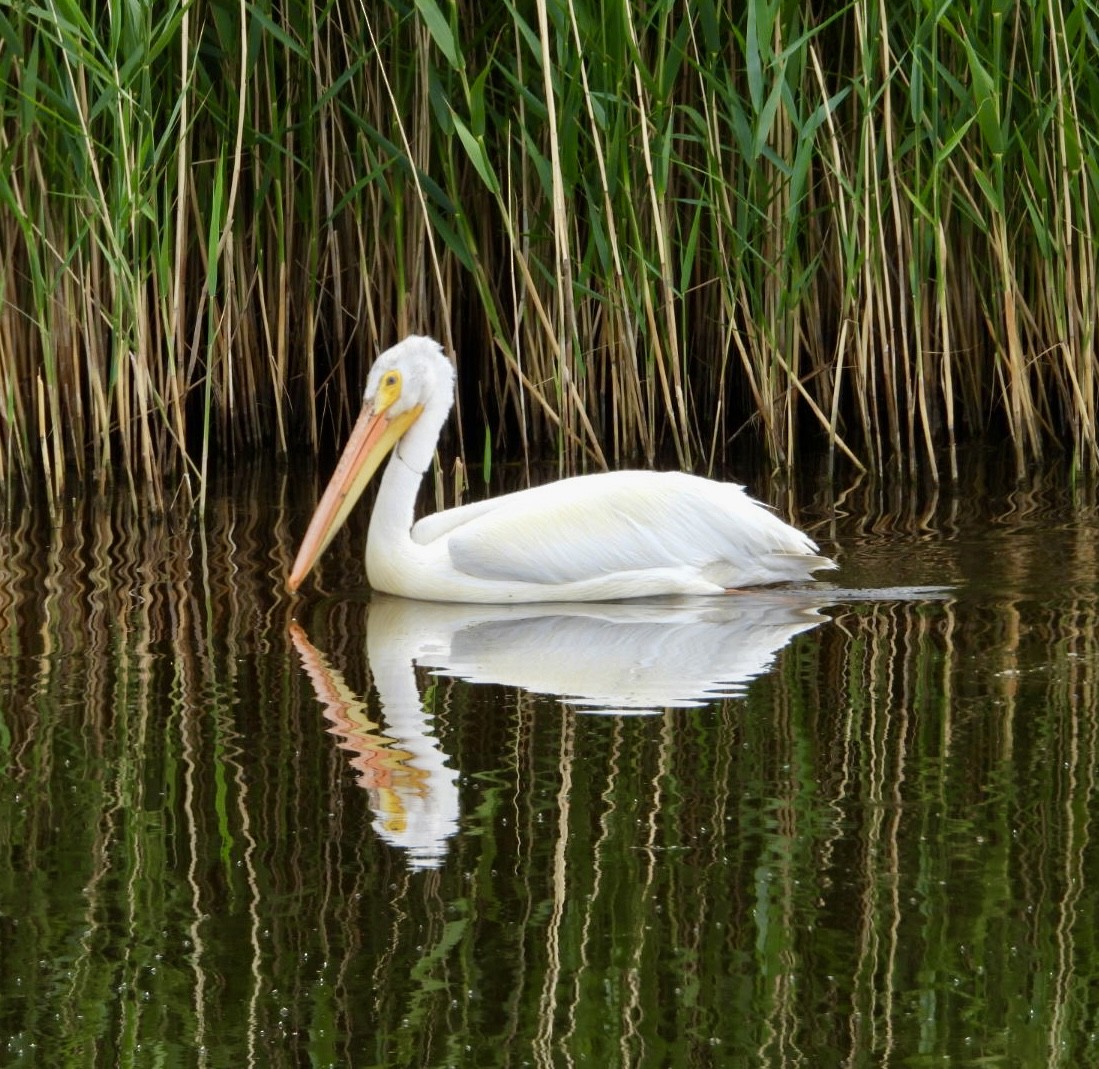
[424,471,829,587]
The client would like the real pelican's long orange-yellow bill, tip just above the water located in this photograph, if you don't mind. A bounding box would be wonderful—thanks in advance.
[286,404,423,593]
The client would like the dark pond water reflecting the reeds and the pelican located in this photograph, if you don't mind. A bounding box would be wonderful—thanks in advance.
[0,454,1099,1069]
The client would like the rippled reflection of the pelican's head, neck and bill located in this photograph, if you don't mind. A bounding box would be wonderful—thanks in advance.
[290,624,459,868]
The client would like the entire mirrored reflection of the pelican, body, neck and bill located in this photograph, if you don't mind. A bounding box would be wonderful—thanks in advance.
[290,591,825,868]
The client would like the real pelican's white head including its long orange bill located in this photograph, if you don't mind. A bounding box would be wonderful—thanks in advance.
[286,336,454,592]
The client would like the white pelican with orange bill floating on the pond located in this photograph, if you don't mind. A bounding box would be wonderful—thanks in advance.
[287,336,835,603]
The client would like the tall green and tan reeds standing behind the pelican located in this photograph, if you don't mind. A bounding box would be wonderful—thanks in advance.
[0,0,1099,504]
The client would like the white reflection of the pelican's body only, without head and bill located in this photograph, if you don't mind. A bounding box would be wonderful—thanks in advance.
[367,591,826,712]
